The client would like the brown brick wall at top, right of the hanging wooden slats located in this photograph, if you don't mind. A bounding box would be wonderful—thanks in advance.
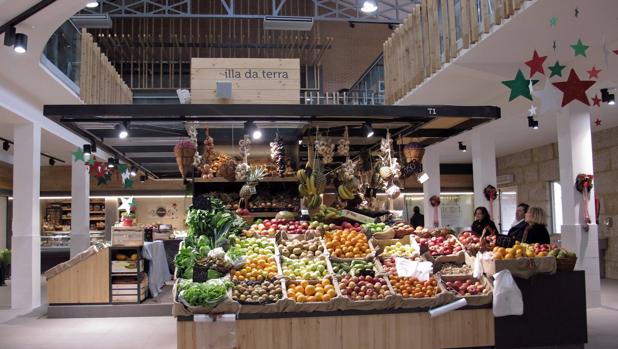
[320,22,391,92]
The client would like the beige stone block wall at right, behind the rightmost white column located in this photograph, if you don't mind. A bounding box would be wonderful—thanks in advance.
[496,127,618,279]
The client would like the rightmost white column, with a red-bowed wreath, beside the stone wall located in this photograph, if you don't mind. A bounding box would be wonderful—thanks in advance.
[558,102,601,307]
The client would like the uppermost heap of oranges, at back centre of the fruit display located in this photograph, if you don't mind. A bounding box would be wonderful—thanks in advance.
[324,223,371,258]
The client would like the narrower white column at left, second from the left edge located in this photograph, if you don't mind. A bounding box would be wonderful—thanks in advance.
[71,161,90,257]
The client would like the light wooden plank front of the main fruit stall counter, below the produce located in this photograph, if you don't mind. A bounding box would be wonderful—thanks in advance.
[177,308,495,349]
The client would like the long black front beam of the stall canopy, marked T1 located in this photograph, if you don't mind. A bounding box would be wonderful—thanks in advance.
[43,104,500,122]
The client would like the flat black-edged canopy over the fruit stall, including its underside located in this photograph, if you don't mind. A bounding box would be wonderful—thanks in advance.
[43,104,500,178]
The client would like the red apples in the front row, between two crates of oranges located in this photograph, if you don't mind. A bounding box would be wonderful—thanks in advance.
[339,275,391,301]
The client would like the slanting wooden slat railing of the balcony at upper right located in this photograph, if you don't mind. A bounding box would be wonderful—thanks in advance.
[383,0,524,104]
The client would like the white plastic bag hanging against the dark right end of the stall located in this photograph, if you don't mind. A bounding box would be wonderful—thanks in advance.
[493,270,524,317]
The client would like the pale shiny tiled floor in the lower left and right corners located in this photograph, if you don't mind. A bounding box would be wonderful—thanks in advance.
[0,280,618,349]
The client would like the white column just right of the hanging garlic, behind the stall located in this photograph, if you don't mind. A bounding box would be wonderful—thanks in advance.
[423,147,442,227]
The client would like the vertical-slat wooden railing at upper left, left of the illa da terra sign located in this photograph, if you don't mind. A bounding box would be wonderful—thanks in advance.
[79,30,133,104]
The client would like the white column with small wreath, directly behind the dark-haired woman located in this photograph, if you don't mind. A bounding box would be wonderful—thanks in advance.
[468,127,500,220]
